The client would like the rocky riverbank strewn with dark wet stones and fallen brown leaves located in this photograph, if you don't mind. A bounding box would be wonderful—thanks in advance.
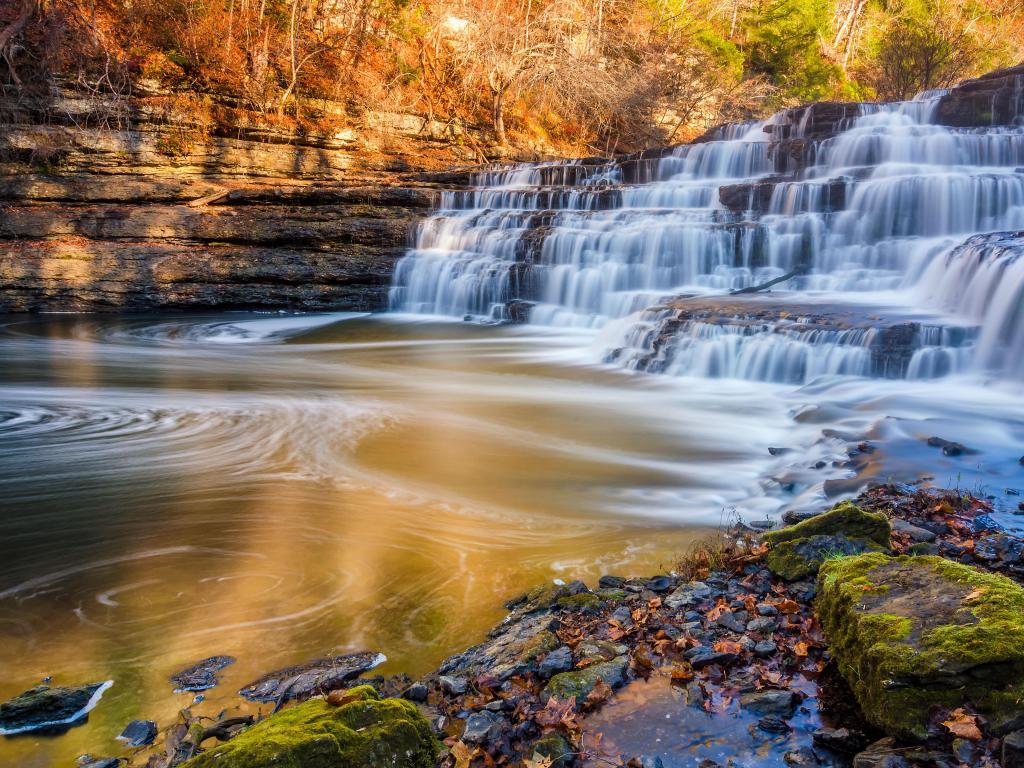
[12,485,1024,768]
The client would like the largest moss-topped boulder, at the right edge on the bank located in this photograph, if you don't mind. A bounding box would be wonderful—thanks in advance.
[815,553,1024,738]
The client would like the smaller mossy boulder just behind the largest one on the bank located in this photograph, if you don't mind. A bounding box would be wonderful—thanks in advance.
[764,502,891,582]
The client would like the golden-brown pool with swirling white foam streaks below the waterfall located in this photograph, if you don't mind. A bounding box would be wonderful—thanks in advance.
[0,319,737,768]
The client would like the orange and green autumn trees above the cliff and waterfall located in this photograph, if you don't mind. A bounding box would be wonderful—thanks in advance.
[0,0,1024,152]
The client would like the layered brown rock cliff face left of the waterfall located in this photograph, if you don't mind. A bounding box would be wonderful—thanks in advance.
[0,92,472,311]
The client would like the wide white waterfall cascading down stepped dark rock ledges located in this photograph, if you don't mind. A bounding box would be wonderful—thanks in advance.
[391,77,1024,383]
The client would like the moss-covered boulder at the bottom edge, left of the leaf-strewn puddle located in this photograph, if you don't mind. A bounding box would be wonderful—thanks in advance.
[184,685,438,768]
